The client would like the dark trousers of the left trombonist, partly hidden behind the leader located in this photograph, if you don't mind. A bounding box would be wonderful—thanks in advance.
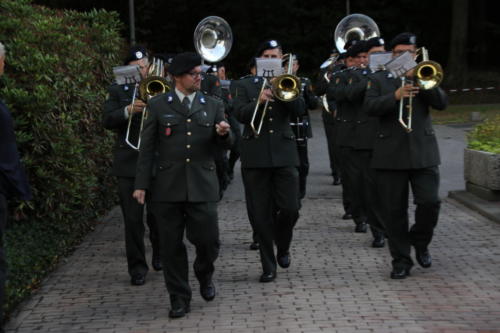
[118,177,160,276]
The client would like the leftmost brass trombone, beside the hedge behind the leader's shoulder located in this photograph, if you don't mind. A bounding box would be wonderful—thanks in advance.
[125,58,170,150]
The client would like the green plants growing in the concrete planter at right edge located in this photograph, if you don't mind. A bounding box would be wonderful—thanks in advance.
[468,114,500,154]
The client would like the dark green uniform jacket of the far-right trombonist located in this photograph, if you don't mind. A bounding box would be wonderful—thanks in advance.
[364,71,448,169]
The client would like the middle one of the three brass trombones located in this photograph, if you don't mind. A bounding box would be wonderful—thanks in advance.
[250,53,301,137]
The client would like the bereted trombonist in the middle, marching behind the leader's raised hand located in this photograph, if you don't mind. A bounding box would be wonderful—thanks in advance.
[233,40,305,282]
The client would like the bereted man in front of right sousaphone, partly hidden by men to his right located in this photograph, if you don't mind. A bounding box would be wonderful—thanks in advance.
[327,40,367,233]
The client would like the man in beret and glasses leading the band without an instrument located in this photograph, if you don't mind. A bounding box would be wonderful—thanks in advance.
[134,52,232,318]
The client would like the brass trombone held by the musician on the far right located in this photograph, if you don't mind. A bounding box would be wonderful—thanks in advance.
[398,47,444,133]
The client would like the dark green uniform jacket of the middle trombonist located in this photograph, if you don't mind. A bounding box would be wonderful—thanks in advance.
[233,76,305,168]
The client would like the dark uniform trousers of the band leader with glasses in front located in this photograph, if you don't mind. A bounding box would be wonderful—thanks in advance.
[150,202,220,304]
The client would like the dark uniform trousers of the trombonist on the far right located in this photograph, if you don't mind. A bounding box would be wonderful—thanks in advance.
[376,166,441,268]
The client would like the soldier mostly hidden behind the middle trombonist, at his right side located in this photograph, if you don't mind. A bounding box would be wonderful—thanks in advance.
[285,54,318,199]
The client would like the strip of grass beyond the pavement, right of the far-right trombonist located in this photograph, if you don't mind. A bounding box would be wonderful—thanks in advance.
[431,104,500,124]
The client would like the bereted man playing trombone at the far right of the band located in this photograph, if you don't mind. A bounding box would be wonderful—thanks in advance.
[364,33,447,279]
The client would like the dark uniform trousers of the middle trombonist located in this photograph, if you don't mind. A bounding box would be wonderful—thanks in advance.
[241,166,299,273]
